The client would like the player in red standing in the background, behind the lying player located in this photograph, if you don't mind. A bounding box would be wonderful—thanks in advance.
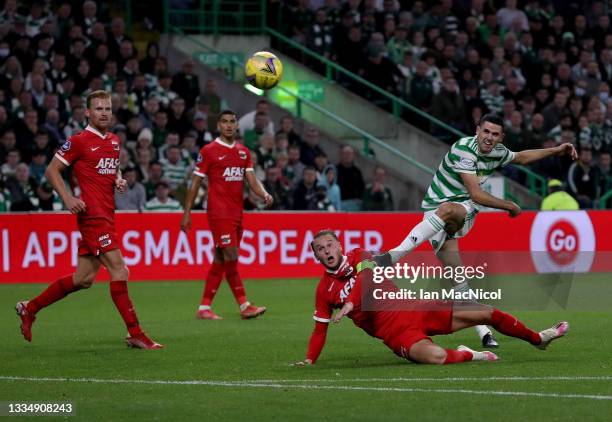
[181,110,272,320]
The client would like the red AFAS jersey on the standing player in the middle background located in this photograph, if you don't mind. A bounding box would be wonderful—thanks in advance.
[194,138,253,220]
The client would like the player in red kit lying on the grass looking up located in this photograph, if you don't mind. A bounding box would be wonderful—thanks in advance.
[297,230,569,365]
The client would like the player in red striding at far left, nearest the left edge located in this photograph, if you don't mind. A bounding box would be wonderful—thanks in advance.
[16,91,163,349]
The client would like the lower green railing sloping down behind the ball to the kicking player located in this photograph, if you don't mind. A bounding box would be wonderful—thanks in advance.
[168,25,435,181]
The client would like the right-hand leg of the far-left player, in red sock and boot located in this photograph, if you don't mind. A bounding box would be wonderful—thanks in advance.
[100,249,164,349]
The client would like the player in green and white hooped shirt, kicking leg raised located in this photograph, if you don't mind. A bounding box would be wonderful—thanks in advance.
[376,114,577,347]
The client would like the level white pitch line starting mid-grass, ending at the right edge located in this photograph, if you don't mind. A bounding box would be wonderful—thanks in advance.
[249,376,612,383]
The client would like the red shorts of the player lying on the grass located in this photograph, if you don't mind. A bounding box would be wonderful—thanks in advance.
[384,301,453,359]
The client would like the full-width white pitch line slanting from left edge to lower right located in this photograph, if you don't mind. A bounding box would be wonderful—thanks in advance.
[0,376,612,400]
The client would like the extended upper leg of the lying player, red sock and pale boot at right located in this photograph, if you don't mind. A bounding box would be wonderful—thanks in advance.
[453,304,569,350]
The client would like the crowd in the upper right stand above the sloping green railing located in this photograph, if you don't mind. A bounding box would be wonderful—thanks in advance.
[273,0,612,208]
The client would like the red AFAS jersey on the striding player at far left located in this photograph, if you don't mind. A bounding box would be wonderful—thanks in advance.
[55,126,121,222]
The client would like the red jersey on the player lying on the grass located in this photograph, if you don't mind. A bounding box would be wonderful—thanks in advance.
[313,248,401,339]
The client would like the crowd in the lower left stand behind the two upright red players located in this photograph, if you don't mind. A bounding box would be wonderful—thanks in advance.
[0,0,393,211]
